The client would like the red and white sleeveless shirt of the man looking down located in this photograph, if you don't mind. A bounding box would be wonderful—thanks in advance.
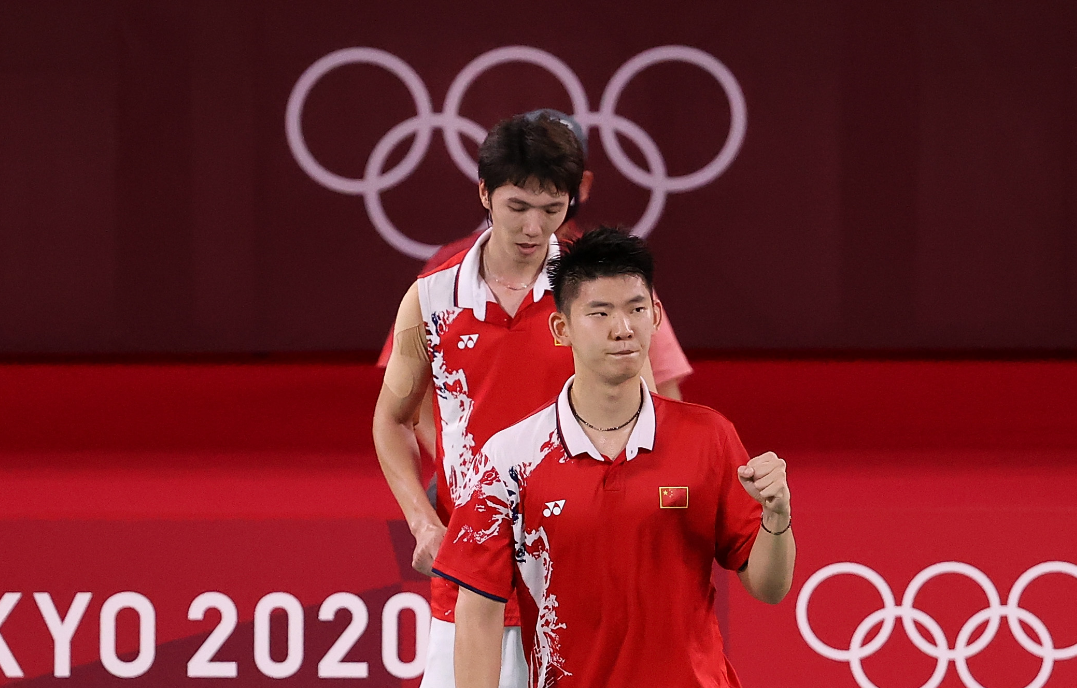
[419,230,572,626]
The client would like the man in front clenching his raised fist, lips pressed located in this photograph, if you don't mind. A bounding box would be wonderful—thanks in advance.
[434,229,796,688]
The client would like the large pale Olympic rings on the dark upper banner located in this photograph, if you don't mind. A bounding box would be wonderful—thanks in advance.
[284,45,747,259]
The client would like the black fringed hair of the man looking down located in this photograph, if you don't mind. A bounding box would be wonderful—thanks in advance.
[478,113,586,197]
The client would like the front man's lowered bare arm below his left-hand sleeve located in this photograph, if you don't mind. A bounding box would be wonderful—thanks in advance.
[453,588,505,688]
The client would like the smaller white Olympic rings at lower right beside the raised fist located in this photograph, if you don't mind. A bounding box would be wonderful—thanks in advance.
[796,561,1077,688]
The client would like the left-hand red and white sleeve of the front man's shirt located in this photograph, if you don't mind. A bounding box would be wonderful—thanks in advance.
[434,455,519,602]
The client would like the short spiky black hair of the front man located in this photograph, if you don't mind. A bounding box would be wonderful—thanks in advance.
[546,226,655,313]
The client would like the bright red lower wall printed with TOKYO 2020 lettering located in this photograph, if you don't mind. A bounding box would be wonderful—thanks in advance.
[0,361,1077,688]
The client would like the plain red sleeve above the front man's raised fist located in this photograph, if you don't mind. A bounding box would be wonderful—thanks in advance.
[714,419,763,571]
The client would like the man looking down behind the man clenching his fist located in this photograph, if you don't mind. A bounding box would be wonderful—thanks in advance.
[374,115,649,688]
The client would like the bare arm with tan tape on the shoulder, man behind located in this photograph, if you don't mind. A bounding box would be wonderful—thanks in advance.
[374,284,445,576]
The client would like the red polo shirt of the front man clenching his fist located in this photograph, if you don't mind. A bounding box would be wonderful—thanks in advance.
[434,379,761,688]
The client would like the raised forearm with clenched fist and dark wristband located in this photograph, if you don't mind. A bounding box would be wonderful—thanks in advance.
[738,451,797,604]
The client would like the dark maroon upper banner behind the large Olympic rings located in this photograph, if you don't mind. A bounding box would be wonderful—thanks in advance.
[0,0,1077,354]
